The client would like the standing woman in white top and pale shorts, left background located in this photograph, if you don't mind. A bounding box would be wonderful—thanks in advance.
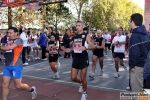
[31,31,40,60]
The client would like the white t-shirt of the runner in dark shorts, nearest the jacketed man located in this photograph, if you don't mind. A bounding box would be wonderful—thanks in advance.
[112,35,126,53]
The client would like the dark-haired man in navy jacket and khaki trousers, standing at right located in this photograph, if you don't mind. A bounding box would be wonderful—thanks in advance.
[129,13,150,92]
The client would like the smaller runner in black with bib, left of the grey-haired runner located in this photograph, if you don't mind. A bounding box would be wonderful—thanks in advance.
[46,35,59,79]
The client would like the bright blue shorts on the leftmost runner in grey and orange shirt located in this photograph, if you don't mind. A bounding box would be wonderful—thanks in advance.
[3,66,23,79]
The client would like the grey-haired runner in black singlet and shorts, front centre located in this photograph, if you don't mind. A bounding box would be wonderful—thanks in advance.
[71,21,94,100]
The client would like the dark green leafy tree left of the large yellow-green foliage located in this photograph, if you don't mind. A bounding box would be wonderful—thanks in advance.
[46,4,72,30]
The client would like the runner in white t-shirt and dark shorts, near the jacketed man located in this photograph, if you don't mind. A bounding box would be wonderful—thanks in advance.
[112,27,127,78]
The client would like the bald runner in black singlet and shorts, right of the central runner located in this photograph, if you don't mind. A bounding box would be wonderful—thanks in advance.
[89,30,105,79]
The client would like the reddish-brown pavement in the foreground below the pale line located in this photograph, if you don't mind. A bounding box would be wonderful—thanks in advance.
[0,76,120,100]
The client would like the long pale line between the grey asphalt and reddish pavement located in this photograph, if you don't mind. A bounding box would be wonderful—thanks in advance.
[23,75,127,92]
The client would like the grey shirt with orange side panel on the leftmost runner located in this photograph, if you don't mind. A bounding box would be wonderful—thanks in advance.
[4,38,23,67]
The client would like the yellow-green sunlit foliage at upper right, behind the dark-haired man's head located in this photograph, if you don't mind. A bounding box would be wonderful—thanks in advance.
[82,0,144,30]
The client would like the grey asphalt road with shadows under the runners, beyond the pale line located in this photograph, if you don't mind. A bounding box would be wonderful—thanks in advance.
[0,51,129,92]
